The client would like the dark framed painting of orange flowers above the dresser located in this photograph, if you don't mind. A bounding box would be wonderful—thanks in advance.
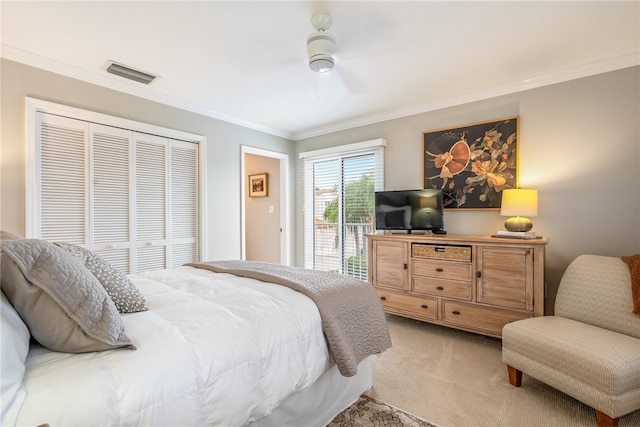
[423,116,518,209]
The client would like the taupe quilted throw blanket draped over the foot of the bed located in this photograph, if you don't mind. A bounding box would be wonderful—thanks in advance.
[186,261,391,377]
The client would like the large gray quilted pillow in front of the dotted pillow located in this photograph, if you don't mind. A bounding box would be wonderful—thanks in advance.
[0,239,135,353]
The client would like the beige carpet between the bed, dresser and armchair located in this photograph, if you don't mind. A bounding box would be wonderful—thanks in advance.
[366,315,640,427]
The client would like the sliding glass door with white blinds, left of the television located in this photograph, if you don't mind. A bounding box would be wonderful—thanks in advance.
[300,139,386,280]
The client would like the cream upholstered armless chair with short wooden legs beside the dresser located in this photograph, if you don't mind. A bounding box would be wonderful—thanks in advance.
[502,255,640,426]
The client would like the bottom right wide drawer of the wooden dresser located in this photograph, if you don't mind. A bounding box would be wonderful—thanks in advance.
[442,301,533,336]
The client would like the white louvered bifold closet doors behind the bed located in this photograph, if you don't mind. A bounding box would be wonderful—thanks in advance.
[27,101,202,274]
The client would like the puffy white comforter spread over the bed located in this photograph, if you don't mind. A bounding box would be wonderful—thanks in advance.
[12,267,329,427]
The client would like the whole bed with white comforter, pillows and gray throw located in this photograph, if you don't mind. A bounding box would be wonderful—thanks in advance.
[0,239,391,427]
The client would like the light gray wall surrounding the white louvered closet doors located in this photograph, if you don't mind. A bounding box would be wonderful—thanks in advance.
[0,59,295,260]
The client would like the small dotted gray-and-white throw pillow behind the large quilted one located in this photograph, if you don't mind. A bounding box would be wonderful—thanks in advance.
[56,242,147,313]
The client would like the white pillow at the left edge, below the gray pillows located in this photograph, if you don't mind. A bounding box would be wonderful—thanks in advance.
[0,293,30,426]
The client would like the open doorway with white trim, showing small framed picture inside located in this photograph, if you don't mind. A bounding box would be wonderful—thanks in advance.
[240,145,291,265]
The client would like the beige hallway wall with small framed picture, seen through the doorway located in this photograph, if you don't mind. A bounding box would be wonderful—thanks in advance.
[245,154,280,263]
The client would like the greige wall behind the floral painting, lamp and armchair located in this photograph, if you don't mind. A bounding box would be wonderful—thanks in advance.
[295,67,640,314]
